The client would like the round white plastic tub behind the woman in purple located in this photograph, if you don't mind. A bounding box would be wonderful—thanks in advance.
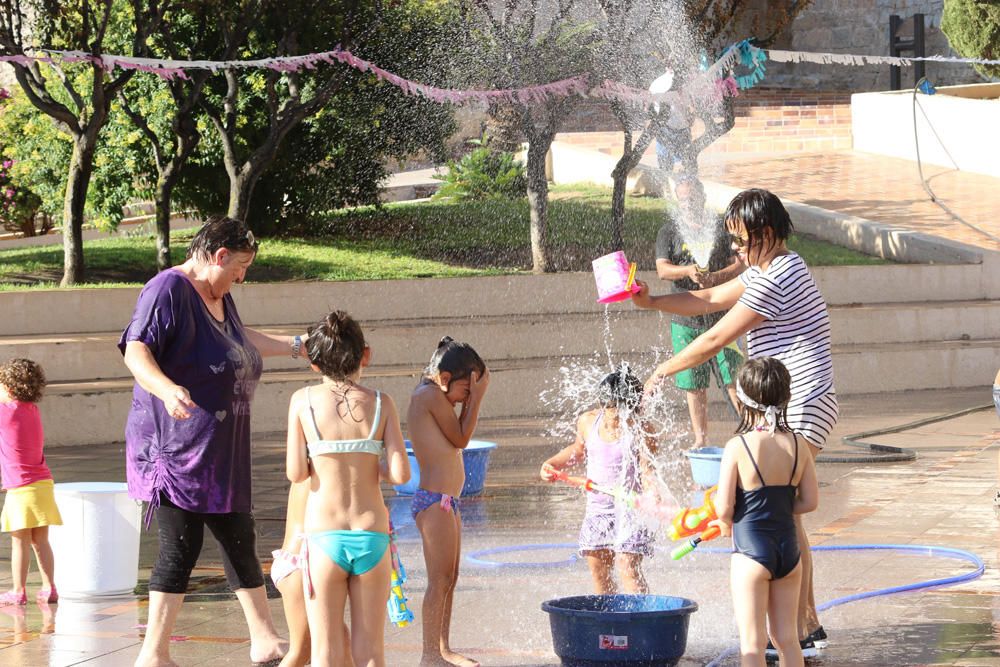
[49,482,142,599]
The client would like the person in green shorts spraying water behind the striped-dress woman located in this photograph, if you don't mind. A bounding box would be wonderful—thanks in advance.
[656,178,746,447]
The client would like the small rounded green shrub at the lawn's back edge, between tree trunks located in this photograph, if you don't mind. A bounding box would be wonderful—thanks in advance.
[434,135,527,201]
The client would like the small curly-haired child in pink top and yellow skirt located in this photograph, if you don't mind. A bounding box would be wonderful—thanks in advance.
[0,359,62,606]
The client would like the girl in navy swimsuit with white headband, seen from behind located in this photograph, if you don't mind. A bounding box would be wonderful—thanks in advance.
[713,357,819,667]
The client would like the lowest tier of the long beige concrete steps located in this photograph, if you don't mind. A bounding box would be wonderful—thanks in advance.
[42,339,1000,445]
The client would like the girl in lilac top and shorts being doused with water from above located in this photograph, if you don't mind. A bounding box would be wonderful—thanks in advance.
[539,364,656,595]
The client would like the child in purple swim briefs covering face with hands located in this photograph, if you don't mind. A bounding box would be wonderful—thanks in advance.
[407,336,490,667]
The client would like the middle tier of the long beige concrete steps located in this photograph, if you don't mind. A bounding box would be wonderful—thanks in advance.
[7,301,1000,389]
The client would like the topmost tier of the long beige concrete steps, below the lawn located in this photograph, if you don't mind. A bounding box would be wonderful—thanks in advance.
[0,268,1000,337]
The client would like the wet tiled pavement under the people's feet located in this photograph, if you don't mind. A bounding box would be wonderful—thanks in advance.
[0,388,1000,667]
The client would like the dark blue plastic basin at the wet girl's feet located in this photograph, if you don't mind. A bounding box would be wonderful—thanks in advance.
[542,595,698,667]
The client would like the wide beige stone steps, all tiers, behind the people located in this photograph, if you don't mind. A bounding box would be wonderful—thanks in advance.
[7,263,1000,445]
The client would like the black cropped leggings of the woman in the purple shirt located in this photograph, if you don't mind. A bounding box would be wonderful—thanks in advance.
[149,497,264,593]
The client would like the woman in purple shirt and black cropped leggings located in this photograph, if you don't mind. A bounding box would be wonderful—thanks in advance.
[118,217,302,665]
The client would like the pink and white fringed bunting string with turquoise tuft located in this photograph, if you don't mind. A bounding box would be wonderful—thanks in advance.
[0,40,1000,107]
